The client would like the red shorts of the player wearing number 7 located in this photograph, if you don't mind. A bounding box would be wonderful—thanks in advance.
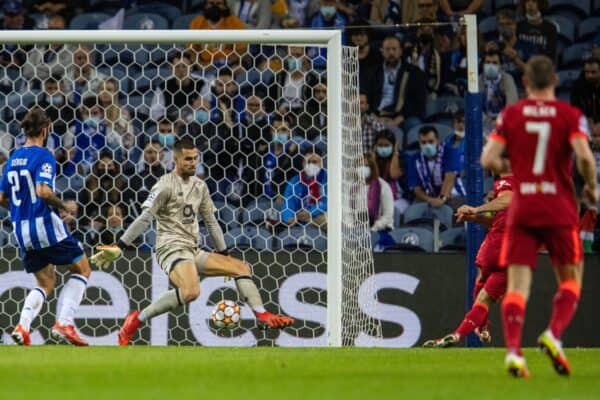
[500,225,583,268]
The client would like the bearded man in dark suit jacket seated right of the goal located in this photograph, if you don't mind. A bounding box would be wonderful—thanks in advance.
[363,36,427,131]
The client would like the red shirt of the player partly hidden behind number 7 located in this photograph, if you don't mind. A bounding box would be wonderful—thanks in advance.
[475,175,514,267]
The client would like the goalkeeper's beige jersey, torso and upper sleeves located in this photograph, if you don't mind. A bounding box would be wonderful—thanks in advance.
[142,172,214,251]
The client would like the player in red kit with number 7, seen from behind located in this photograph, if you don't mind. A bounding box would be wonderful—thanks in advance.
[481,56,598,377]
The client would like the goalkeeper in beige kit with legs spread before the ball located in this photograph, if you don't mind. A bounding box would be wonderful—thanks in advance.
[90,138,294,346]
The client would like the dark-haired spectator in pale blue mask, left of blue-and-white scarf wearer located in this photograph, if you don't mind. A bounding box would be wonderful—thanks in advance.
[373,130,408,214]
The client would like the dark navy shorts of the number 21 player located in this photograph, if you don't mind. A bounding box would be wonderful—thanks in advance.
[23,235,85,274]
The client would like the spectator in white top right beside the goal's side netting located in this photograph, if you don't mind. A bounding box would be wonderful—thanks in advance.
[359,153,394,232]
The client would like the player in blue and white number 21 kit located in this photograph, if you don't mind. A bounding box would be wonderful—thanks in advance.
[0,107,90,346]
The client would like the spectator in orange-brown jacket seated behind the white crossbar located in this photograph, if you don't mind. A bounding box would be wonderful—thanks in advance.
[190,0,247,68]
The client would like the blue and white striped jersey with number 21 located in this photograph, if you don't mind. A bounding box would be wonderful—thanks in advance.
[0,146,69,251]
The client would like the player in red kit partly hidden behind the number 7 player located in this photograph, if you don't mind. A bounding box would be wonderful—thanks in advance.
[423,174,514,347]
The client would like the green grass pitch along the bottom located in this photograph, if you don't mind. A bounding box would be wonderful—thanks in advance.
[0,346,600,400]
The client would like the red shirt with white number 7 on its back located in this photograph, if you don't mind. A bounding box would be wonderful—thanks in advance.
[490,99,589,227]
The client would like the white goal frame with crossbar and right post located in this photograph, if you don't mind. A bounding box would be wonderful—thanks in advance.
[0,29,343,347]
